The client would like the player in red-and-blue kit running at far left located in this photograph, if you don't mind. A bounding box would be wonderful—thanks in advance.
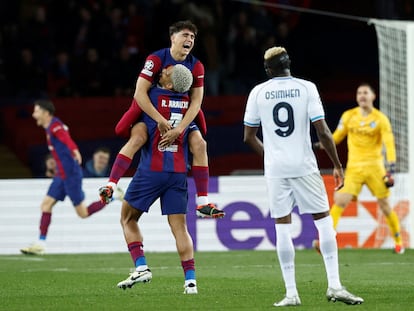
[20,100,115,255]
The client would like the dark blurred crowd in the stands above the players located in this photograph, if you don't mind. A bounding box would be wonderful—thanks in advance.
[0,0,413,101]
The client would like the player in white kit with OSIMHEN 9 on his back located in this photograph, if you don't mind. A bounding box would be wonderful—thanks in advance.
[244,47,364,307]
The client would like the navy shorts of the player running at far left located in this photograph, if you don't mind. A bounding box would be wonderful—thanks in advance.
[47,174,85,206]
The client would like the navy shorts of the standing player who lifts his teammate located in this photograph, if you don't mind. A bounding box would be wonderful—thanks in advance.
[124,170,188,215]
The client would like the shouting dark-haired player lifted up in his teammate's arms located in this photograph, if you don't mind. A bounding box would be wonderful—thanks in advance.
[99,21,224,218]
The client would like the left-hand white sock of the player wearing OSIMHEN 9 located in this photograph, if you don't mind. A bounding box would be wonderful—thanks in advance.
[276,224,298,297]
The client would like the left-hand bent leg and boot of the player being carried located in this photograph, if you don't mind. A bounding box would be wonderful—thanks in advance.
[99,122,148,203]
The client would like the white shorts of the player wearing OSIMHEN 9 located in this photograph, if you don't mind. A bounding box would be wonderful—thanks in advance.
[266,173,329,218]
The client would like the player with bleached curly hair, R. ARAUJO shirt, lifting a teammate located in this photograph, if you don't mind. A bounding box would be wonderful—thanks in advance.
[117,64,197,294]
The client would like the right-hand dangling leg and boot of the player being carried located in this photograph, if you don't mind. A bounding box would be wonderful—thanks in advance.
[188,131,225,218]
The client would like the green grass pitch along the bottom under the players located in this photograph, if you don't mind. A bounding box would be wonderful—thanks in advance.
[0,249,414,311]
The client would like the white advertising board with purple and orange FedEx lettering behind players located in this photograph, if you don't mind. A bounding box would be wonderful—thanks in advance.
[187,176,409,251]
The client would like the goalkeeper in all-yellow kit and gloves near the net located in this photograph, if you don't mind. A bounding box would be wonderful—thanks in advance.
[315,83,404,254]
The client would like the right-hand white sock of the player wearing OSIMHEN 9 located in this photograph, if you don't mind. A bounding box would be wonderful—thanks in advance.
[314,216,342,289]
